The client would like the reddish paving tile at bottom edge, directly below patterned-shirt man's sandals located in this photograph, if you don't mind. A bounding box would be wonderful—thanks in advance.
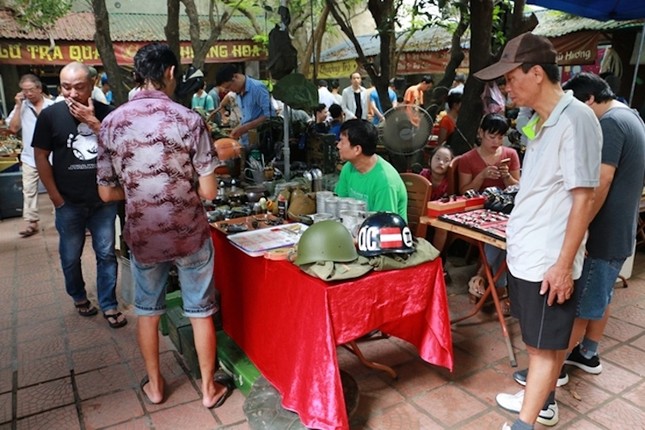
[151,400,219,430]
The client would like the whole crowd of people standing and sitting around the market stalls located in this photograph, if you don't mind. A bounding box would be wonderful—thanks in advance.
[1,33,645,430]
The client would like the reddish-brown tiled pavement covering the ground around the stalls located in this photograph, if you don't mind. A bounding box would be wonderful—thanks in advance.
[0,195,645,430]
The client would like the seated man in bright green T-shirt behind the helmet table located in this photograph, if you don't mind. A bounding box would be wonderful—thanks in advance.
[334,119,408,222]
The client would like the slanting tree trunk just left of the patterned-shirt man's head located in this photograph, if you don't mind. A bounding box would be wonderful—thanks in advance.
[92,0,131,106]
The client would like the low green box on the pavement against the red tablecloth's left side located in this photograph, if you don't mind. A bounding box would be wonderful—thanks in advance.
[217,330,261,396]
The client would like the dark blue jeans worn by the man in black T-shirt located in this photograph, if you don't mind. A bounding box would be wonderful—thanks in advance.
[56,202,118,312]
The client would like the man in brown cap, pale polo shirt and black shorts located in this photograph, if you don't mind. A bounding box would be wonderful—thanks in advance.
[475,33,602,430]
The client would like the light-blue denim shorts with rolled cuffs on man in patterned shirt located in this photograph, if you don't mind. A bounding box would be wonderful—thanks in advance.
[131,238,217,318]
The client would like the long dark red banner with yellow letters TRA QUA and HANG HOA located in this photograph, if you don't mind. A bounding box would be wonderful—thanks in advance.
[0,40,267,66]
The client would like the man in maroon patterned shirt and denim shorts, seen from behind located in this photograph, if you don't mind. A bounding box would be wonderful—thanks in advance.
[97,44,233,408]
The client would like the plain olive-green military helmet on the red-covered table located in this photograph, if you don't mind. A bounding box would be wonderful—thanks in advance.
[294,220,358,266]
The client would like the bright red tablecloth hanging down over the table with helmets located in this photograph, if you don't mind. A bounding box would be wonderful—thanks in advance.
[213,229,453,429]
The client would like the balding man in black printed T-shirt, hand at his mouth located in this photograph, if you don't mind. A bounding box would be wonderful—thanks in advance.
[33,62,128,328]
